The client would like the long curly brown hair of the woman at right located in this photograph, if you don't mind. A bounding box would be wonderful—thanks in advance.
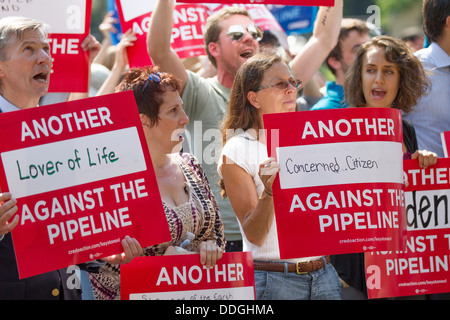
[344,36,431,113]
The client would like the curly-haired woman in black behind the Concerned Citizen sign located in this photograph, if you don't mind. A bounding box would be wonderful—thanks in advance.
[338,36,437,300]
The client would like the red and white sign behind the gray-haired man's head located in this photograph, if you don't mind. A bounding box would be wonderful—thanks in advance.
[0,0,92,92]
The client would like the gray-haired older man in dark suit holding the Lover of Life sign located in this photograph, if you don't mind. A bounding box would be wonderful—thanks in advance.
[0,17,142,300]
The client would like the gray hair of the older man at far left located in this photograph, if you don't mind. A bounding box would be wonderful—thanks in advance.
[0,17,48,61]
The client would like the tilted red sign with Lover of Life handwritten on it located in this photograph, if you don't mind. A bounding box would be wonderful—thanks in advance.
[0,91,170,278]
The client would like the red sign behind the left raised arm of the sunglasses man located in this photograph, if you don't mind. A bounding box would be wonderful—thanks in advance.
[117,0,211,67]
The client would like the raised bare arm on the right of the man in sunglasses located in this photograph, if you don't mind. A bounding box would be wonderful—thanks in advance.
[291,0,343,84]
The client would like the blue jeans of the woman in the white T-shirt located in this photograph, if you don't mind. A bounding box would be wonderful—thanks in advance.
[255,263,341,300]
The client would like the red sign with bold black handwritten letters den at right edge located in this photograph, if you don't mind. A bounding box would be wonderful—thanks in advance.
[365,158,450,299]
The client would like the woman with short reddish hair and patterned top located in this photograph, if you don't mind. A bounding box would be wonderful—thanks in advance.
[89,67,225,300]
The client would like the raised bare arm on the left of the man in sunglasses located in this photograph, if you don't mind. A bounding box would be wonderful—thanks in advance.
[147,0,188,93]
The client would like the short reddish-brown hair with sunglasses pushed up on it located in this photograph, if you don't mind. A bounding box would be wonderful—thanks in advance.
[116,67,181,126]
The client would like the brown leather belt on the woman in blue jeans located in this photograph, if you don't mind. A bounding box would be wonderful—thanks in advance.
[253,256,330,274]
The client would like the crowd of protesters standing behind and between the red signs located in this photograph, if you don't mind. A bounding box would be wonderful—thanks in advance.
[0,0,450,300]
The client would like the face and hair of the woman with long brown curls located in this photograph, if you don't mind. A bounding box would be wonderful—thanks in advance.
[344,36,430,112]
